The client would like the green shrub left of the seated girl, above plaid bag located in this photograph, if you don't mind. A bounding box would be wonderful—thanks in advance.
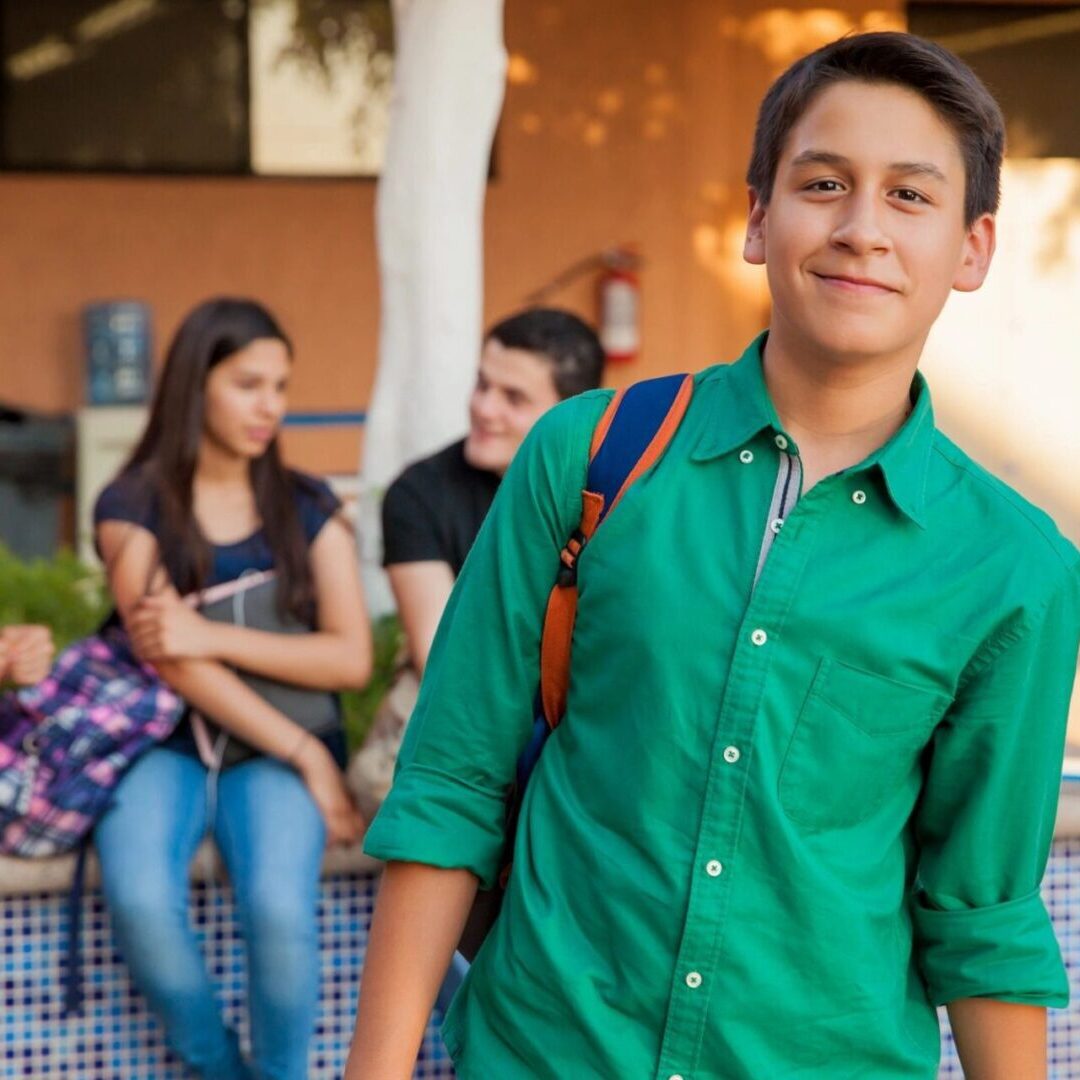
[0,544,111,649]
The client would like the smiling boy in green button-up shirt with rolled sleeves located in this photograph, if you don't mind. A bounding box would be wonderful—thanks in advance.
[347,33,1080,1080]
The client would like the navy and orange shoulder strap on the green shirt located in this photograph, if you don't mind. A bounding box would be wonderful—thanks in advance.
[539,375,693,730]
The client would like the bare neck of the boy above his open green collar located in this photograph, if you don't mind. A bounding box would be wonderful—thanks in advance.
[762,317,919,494]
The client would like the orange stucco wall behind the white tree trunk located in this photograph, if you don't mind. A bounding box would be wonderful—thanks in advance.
[0,0,901,471]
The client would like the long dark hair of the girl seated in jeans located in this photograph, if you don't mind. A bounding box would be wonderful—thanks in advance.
[120,297,314,622]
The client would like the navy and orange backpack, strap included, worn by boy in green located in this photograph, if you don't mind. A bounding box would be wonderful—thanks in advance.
[458,375,693,961]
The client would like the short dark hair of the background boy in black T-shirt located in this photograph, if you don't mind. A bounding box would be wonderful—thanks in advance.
[484,308,604,400]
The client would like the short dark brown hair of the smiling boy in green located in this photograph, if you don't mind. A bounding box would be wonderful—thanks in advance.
[746,31,1005,225]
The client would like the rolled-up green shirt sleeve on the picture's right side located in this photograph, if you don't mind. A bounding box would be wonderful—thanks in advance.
[913,563,1080,1008]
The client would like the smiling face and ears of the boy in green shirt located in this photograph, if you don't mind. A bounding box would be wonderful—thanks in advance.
[744,81,994,362]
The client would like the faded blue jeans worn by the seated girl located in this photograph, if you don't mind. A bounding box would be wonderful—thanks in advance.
[94,747,326,1080]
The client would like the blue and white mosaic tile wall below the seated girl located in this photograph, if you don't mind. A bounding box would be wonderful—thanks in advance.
[0,839,1080,1080]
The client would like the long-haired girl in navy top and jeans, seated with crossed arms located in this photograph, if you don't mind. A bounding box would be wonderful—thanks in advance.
[94,299,372,1080]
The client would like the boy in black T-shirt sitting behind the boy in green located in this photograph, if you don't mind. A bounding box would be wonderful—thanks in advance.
[382,308,604,675]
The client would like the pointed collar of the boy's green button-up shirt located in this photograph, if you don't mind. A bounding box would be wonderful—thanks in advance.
[690,332,934,527]
